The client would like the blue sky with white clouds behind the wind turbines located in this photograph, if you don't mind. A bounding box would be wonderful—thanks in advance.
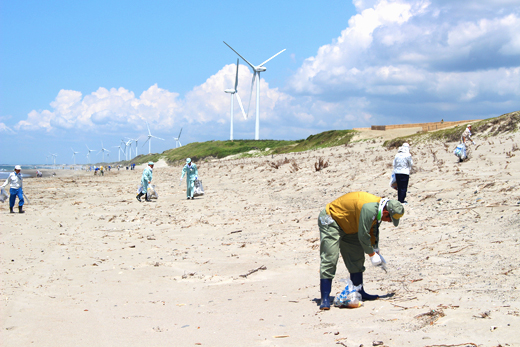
[0,0,520,164]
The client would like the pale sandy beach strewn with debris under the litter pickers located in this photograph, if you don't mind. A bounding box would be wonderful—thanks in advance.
[0,134,520,347]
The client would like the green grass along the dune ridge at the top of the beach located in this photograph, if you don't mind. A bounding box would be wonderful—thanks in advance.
[115,111,520,165]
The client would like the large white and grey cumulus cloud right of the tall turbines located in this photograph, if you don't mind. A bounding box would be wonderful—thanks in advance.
[287,0,520,122]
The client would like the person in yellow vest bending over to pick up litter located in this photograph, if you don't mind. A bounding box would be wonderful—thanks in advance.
[318,192,404,310]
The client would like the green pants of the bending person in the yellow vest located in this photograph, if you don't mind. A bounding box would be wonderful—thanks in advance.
[318,209,365,278]
